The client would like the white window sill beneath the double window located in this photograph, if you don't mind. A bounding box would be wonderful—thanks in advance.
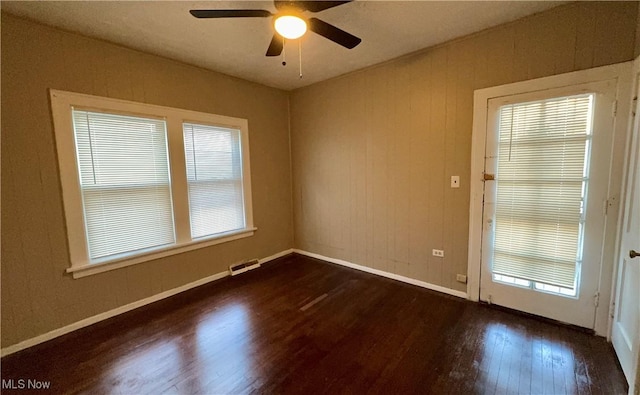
[67,227,258,278]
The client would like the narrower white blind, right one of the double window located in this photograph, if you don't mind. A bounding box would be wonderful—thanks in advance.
[183,123,245,238]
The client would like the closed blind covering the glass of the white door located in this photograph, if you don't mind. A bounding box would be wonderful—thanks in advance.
[492,95,593,289]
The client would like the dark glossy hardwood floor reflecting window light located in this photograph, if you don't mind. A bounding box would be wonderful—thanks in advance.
[1,255,627,394]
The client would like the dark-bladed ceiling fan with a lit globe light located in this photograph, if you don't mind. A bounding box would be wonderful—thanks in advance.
[189,0,362,56]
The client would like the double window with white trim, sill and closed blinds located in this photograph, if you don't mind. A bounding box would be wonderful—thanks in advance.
[51,90,255,277]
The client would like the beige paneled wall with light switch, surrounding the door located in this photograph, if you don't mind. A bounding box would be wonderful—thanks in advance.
[291,2,638,290]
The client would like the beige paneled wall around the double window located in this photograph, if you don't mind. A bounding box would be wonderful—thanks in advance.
[1,14,293,347]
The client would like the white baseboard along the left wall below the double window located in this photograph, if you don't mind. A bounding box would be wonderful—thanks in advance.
[0,249,293,357]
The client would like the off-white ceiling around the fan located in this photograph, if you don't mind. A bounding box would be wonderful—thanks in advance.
[2,0,566,90]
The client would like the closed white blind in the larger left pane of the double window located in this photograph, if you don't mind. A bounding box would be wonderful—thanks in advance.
[73,109,175,260]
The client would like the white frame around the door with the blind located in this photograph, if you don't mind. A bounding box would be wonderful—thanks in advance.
[467,62,633,338]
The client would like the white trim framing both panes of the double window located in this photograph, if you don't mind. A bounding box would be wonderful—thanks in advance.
[50,89,257,278]
